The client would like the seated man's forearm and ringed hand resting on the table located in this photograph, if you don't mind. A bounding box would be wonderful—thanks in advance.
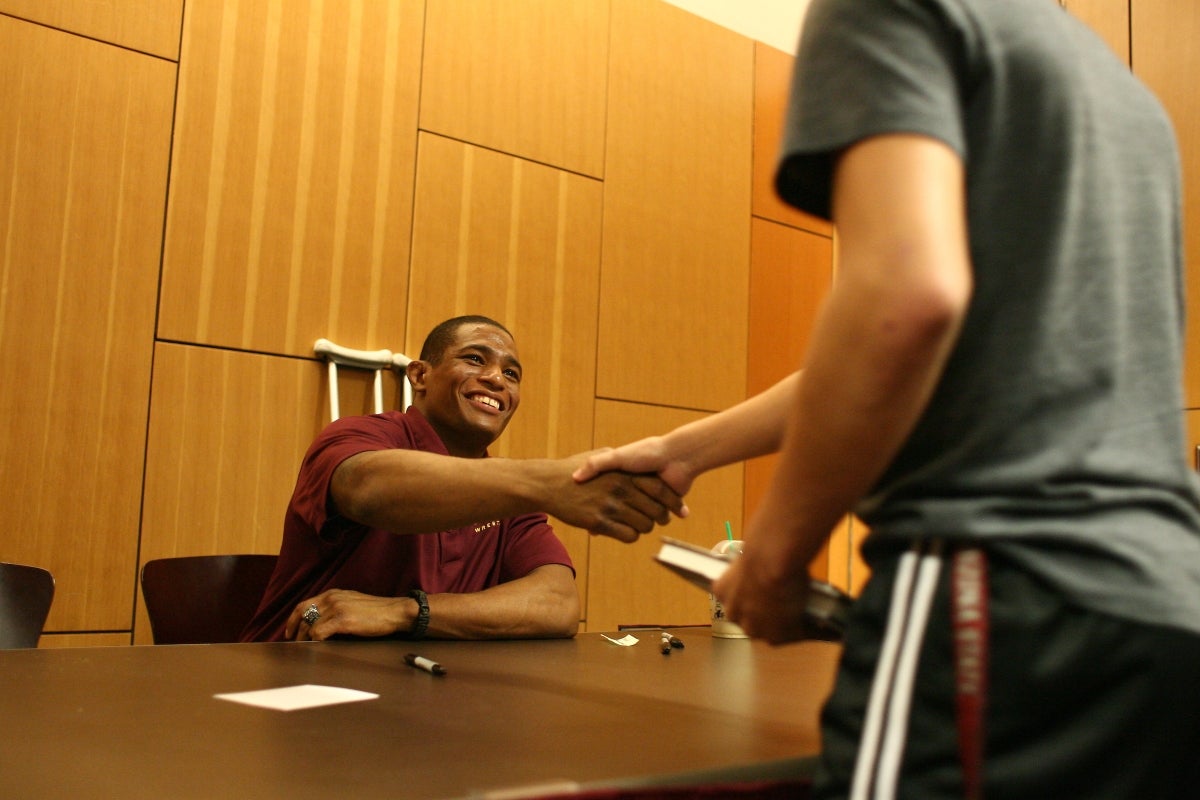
[286,564,580,640]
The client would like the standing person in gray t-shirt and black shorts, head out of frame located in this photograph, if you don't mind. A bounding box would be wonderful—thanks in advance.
[577,0,1200,800]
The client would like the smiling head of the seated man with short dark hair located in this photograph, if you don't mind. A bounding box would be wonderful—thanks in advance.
[408,323,521,458]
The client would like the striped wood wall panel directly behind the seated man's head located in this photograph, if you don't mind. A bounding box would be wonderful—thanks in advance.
[406,133,601,606]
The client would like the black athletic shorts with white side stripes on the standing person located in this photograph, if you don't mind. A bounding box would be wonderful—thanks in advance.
[814,543,1200,800]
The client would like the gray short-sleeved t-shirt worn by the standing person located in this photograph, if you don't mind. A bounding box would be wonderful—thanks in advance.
[776,0,1200,631]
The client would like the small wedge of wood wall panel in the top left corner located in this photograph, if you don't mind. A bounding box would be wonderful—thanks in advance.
[0,0,184,61]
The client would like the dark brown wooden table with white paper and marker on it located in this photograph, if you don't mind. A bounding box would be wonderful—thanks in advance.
[0,628,839,799]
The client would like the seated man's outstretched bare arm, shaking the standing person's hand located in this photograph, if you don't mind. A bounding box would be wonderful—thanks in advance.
[330,450,683,541]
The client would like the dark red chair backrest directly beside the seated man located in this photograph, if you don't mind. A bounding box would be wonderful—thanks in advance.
[142,554,278,644]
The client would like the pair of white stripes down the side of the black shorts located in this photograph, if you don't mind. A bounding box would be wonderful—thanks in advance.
[850,541,942,800]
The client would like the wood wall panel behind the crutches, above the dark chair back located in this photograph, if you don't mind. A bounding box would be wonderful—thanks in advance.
[134,343,397,644]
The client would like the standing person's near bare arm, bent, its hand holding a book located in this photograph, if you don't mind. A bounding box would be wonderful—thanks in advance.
[715,136,972,642]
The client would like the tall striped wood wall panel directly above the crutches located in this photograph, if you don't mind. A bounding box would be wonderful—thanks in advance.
[158,0,421,355]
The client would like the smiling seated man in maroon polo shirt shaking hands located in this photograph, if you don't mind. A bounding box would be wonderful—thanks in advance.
[241,317,683,642]
